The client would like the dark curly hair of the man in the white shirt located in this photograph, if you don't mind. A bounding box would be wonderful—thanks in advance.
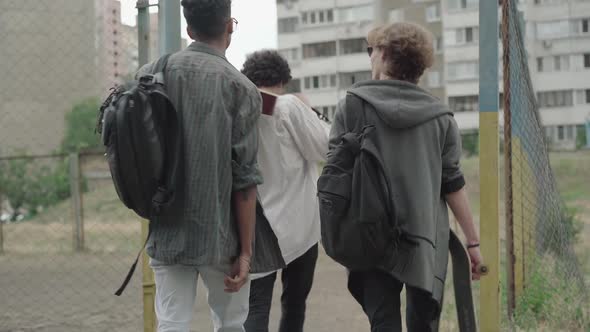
[242,50,291,87]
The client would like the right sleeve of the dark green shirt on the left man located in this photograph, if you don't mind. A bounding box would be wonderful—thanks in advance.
[231,83,262,191]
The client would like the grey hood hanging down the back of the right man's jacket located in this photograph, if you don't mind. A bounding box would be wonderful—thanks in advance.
[349,80,453,129]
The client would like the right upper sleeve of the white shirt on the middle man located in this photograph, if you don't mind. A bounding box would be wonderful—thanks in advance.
[283,96,328,162]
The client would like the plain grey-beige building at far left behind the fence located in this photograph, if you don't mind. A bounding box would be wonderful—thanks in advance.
[0,0,99,156]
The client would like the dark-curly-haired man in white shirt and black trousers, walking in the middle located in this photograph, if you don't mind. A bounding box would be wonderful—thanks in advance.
[242,50,329,332]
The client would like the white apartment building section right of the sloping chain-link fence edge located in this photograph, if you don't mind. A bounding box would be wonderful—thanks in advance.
[523,0,590,149]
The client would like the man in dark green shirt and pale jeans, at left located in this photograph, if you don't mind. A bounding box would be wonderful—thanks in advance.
[142,0,284,332]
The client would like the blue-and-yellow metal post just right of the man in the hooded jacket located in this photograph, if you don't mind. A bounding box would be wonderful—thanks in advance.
[479,0,500,332]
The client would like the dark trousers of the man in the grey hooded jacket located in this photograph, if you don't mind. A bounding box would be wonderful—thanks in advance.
[348,270,440,332]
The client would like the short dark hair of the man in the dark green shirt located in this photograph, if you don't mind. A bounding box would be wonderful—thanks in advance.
[181,0,231,40]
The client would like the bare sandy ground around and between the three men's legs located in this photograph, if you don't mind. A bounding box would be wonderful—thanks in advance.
[0,246,472,332]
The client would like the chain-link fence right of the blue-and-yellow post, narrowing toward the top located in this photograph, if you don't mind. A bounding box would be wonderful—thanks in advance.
[502,1,590,331]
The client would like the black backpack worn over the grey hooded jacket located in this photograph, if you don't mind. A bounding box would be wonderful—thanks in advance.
[318,93,400,270]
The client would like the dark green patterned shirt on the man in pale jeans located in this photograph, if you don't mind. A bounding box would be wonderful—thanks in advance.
[140,42,282,272]
